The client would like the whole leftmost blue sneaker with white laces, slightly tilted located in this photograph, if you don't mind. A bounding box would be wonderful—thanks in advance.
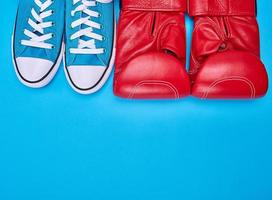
[12,0,65,88]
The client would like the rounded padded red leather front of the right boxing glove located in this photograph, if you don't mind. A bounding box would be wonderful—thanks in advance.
[192,51,268,99]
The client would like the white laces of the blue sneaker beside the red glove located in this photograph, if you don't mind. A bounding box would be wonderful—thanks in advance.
[70,0,112,54]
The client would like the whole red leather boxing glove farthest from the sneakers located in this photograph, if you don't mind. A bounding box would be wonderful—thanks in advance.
[188,0,268,99]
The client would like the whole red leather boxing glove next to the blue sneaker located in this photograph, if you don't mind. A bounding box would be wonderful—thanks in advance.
[114,0,190,99]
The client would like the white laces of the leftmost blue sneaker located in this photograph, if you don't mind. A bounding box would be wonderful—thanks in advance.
[21,0,53,49]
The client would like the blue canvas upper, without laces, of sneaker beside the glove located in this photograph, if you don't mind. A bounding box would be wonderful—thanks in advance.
[65,0,115,66]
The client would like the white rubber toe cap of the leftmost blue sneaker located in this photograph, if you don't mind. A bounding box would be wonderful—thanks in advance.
[16,57,54,82]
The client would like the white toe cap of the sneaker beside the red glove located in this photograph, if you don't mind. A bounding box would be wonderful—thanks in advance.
[67,66,106,94]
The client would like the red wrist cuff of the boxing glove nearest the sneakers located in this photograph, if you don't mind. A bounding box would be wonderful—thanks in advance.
[122,0,187,12]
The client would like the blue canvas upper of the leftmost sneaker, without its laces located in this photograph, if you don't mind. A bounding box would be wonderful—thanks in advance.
[13,0,65,62]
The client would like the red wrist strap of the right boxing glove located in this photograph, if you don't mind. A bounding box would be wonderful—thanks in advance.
[188,0,256,16]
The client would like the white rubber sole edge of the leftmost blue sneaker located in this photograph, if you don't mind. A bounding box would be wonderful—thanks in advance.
[11,30,64,88]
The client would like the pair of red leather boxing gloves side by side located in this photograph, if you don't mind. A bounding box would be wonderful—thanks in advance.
[114,0,268,99]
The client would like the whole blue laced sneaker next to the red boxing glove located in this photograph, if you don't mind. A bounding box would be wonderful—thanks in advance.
[65,0,115,94]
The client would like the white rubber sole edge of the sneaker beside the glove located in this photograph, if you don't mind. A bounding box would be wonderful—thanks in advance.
[63,18,116,95]
